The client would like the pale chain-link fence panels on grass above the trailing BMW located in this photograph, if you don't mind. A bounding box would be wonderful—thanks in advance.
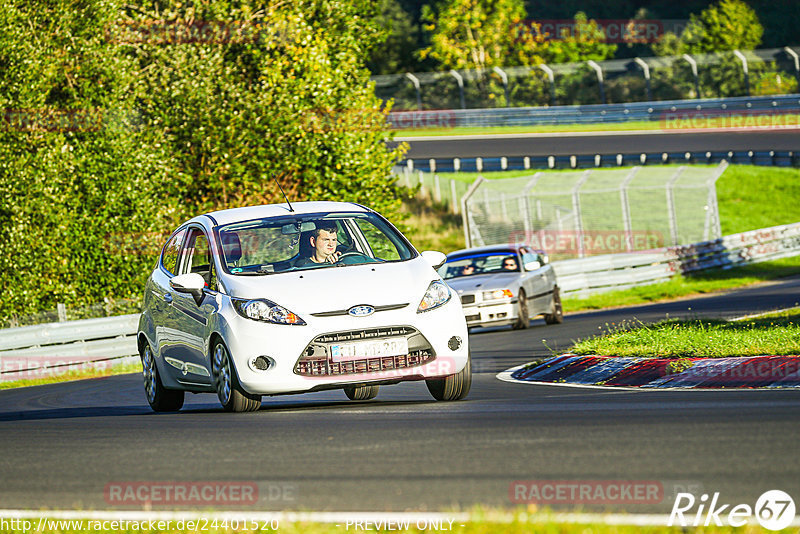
[462,165,728,259]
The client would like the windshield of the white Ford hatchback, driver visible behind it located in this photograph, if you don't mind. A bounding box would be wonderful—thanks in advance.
[216,213,415,275]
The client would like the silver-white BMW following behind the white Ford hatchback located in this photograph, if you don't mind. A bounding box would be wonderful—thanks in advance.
[439,244,564,329]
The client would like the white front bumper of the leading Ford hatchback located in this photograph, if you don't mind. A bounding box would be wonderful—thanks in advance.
[221,298,469,395]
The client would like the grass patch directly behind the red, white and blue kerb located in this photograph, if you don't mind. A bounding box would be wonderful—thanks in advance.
[570,308,800,358]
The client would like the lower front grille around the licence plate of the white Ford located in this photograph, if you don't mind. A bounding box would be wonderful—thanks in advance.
[294,326,436,376]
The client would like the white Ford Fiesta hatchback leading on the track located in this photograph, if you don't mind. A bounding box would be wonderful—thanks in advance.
[137,202,472,412]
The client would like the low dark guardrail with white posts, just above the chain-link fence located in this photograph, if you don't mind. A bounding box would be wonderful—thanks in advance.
[406,150,800,173]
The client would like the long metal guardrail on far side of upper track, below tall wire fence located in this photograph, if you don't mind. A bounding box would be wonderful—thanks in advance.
[388,94,800,129]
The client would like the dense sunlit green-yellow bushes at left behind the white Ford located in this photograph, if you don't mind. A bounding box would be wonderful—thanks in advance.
[0,0,400,317]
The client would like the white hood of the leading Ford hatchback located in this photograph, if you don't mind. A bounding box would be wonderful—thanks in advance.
[225,257,439,317]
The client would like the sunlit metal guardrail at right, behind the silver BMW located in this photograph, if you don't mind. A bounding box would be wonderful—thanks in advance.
[553,223,800,296]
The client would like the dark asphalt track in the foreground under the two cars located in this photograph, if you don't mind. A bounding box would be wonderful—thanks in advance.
[0,278,800,514]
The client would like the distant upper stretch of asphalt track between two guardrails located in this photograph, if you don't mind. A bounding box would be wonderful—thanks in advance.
[395,130,800,159]
